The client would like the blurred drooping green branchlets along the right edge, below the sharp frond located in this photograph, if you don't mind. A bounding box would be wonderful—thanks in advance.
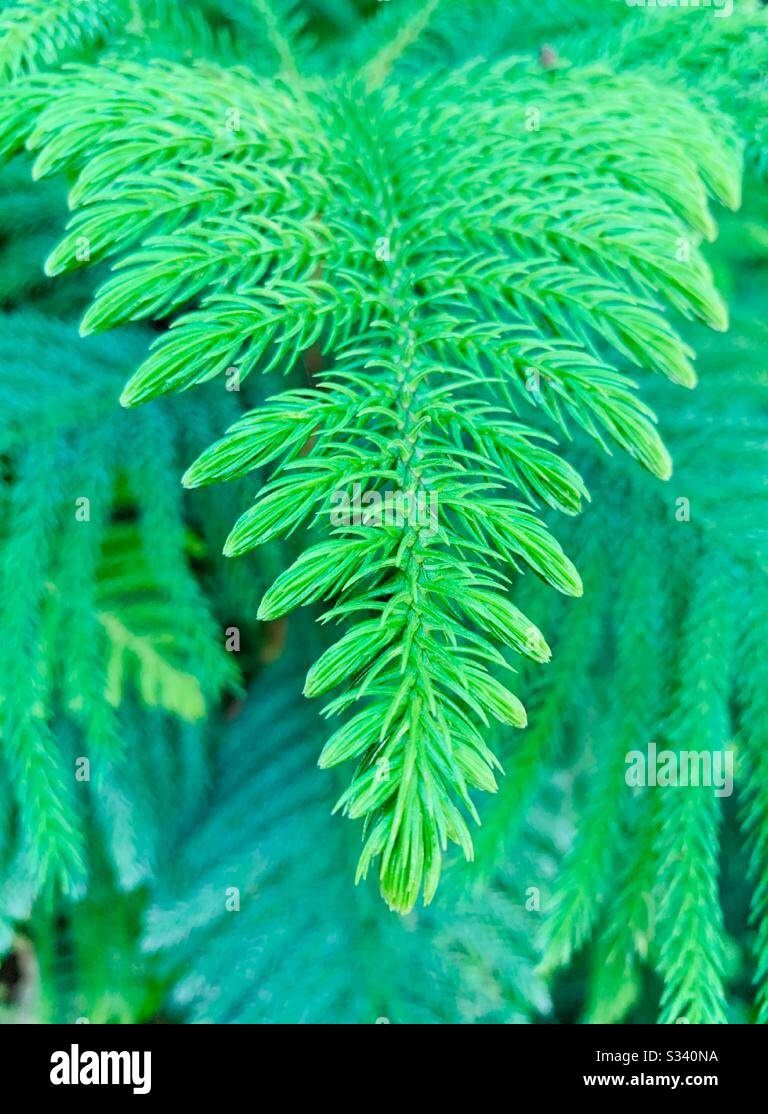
[508,184,768,1023]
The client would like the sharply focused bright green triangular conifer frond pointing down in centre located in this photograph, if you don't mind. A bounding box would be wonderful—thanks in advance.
[2,3,739,910]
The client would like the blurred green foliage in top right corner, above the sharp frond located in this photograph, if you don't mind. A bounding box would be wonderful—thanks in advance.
[394,0,768,174]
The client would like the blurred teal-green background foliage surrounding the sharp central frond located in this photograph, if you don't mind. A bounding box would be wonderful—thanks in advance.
[0,0,768,1024]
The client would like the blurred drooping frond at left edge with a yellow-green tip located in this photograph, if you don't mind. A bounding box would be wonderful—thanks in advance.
[0,310,236,922]
